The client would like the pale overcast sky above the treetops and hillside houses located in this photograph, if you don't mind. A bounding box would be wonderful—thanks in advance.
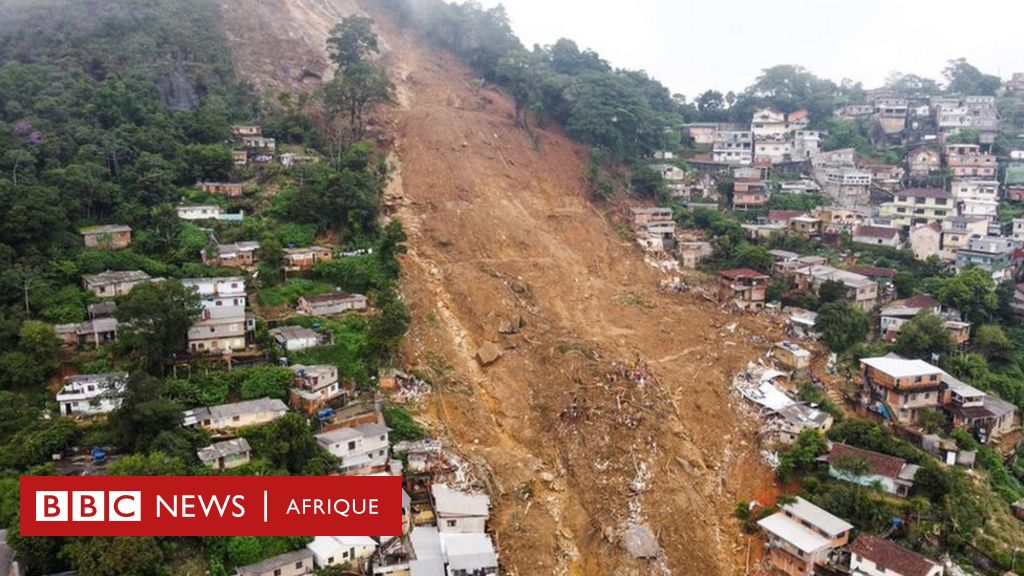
[480,0,1024,98]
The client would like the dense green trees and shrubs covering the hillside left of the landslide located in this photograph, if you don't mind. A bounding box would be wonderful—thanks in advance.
[0,0,407,576]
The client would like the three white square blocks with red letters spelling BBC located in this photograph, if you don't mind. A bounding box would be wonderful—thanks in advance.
[36,490,142,522]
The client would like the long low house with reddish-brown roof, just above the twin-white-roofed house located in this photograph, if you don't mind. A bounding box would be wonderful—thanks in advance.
[822,442,919,498]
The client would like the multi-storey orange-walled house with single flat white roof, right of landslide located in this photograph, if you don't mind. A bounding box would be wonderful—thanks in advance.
[860,355,944,424]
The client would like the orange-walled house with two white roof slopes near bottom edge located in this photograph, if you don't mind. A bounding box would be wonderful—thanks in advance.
[758,497,853,576]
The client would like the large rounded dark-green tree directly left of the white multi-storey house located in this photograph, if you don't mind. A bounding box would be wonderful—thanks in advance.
[117,280,203,375]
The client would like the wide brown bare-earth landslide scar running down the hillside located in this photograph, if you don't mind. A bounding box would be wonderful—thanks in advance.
[221,0,772,575]
